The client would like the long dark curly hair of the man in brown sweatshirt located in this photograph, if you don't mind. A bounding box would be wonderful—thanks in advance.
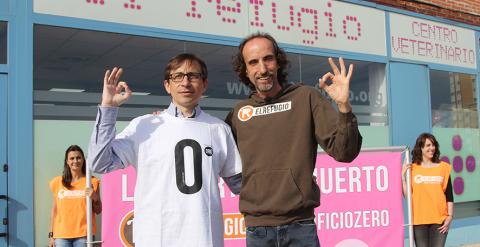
[233,32,288,91]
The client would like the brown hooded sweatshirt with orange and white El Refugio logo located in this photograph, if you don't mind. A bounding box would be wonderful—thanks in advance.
[226,84,362,226]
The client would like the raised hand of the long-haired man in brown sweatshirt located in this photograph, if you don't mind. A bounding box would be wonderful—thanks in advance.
[318,57,353,113]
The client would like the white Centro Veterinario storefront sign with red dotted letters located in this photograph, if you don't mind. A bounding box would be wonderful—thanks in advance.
[390,13,477,69]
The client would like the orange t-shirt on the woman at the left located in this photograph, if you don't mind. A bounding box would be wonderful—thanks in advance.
[49,176,100,238]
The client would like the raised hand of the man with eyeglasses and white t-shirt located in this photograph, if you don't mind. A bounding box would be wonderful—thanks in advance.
[102,67,132,107]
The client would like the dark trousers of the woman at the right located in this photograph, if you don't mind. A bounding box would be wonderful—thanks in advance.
[413,224,448,247]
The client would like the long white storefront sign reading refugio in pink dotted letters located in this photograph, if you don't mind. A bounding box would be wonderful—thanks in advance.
[34,0,386,56]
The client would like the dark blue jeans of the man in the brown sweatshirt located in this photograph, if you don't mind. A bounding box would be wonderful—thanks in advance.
[247,220,320,247]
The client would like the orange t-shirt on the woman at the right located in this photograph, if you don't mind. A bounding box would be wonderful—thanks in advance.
[411,161,452,225]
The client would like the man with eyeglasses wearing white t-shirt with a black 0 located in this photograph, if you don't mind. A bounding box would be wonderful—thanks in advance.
[88,54,241,247]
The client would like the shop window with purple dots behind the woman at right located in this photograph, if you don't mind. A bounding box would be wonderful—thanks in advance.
[430,70,480,202]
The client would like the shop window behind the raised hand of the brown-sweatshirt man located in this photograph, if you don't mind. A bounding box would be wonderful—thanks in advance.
[288,53,389,147]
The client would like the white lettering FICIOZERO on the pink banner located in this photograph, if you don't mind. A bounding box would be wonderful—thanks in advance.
[316,210,390,230]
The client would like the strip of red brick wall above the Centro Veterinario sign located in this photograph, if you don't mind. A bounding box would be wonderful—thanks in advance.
[369,0,480,26]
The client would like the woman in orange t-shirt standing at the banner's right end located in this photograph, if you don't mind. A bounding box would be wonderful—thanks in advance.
[402,133,453,247]
